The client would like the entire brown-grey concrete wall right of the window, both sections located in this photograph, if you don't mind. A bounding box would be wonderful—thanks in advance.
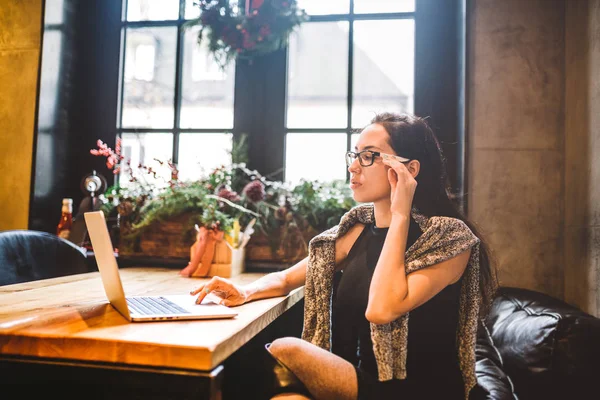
[467,0,600,316]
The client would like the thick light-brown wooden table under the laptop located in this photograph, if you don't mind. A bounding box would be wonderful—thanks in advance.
[0,267,304,400]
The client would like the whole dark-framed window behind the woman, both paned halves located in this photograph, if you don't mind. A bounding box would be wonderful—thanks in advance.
[30,0,468,232]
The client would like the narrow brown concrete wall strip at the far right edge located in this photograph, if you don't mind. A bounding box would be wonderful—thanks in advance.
[564,0,600,315]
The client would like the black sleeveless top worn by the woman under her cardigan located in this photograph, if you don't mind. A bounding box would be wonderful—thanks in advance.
[331,217,464,398]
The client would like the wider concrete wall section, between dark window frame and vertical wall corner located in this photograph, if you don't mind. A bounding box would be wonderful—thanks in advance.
[467,0,565,298]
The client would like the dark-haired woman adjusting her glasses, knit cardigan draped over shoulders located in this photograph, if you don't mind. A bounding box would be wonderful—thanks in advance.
[192,113,497,399]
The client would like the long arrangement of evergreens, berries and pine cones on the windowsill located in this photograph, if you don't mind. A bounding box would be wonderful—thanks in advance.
[90,135,355,262]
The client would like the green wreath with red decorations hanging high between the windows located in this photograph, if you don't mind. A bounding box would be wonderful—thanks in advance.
[190,0,307,69]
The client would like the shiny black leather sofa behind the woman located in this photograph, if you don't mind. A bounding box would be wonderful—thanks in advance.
[471,287,600,400]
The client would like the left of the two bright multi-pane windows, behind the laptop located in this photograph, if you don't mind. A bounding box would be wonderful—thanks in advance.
[117,0,235,186]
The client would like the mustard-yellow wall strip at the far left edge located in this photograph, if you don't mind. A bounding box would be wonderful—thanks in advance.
[0,0,42,230]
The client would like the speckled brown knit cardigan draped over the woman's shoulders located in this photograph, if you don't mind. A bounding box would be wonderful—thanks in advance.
[302,205,481,398]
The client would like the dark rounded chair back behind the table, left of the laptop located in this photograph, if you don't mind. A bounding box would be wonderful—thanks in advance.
[0,230,89,285]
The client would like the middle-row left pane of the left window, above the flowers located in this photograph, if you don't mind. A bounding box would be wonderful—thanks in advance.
[123,27,177,128]
